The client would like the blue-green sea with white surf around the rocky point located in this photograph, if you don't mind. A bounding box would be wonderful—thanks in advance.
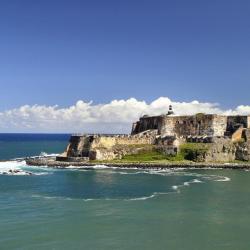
[0,134,250,250]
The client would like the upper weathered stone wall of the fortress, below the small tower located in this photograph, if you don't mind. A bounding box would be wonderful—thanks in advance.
[132,114,250,137]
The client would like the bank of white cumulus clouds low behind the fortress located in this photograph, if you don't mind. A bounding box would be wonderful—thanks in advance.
[0,97,250,133]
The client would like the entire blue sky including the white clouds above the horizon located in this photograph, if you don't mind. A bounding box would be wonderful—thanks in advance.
[0,0,250,132]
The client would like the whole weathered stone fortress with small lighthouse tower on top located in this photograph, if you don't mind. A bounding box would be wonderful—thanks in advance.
[57,105,250,161]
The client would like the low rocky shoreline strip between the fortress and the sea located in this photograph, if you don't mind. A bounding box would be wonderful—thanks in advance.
[23,157,250,169]
